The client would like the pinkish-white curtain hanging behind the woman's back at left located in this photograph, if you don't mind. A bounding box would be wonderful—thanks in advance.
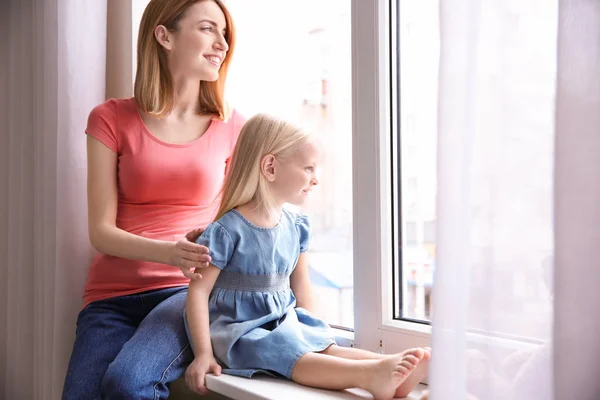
[0,0,106,399]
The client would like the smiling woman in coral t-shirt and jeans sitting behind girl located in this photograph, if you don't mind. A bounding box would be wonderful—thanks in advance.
[63,0,244,400]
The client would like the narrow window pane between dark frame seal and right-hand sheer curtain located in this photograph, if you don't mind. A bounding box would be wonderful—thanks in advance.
[396,0,440,321]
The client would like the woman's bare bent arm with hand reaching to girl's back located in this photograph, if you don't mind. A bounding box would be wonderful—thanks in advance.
[87,135,210,278]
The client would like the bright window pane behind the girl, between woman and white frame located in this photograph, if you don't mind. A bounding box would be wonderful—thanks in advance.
[227,0,354,328]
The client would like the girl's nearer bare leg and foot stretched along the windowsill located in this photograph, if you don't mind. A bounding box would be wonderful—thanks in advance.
[291,350,422,400]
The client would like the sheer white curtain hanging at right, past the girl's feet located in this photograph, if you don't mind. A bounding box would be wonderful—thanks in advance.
[429,0,600,400]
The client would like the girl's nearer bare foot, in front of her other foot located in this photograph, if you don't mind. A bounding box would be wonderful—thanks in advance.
[363,351,422,400]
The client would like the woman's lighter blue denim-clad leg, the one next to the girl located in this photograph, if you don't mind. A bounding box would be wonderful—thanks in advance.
[102,287,193,400]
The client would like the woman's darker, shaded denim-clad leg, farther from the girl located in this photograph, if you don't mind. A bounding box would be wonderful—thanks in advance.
[62,296,139,400]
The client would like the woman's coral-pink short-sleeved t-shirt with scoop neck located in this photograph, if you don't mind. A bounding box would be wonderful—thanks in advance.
[83,98,245,307]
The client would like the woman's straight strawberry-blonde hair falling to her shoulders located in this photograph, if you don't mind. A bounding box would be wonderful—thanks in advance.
[134,0,235,119]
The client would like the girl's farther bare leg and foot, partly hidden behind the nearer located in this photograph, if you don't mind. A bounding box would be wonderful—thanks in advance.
[323,345,431,397]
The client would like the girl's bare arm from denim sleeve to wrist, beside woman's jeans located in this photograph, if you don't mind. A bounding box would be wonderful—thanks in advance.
[186,264,221,358]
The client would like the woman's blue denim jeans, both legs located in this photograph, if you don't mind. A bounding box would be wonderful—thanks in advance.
[62,286,193,400]
